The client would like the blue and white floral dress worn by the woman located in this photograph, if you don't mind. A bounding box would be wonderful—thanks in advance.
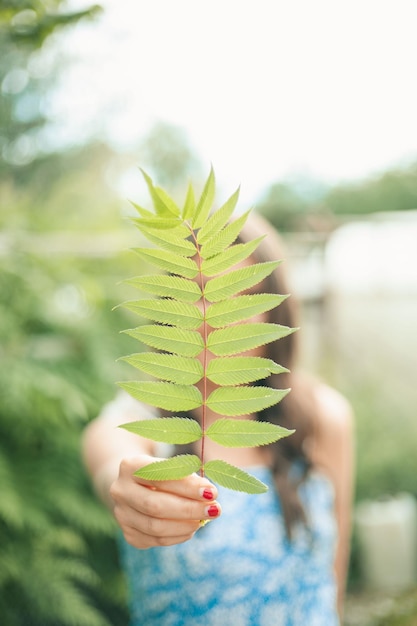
[120,467,339,626]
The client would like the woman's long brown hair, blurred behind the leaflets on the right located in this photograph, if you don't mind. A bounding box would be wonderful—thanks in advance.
[239,213,317,538]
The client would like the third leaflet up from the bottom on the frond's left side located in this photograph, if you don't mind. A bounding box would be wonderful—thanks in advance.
[118,380,203,411]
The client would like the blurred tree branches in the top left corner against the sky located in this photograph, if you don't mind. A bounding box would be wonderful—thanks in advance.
[0,0,99,182]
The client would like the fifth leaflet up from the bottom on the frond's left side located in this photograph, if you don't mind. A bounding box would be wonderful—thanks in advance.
[123,324,204,357]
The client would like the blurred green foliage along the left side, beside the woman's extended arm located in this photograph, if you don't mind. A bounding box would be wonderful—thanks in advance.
[0,150,133,626]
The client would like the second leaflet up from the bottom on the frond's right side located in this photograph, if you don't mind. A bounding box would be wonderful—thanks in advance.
[206,419,295,448]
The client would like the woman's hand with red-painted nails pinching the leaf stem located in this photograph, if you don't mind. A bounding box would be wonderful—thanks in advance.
[110,455,221,549]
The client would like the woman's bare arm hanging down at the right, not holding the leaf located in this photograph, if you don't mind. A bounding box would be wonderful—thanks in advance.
[313,385,354,611]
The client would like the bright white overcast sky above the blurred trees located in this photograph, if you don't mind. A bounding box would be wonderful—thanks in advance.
[51,0,417,199]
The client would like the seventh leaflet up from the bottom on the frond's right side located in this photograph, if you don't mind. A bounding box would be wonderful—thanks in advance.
[204,261,280,302]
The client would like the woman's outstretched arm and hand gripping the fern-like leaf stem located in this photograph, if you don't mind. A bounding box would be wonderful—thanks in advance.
[82,394,221,549]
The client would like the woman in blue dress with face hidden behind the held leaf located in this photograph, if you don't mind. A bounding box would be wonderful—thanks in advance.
[84,215,353,626]
